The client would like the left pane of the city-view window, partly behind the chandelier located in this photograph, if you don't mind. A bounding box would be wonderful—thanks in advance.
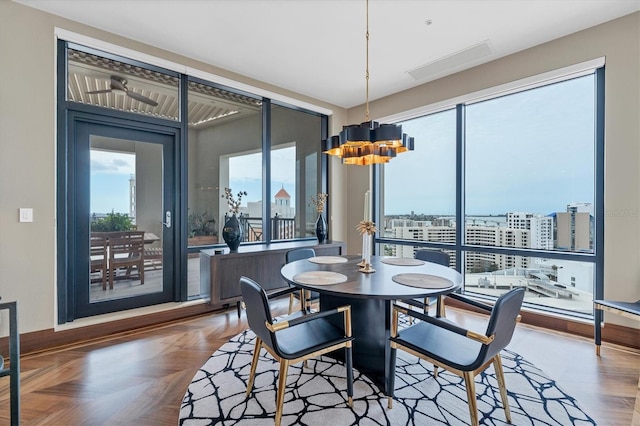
[380,109,456,267]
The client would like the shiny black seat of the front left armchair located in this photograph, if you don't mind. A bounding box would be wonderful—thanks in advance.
[276,318,352,359]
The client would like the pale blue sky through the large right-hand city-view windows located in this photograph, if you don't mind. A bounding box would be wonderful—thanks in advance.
[384,75,595,215]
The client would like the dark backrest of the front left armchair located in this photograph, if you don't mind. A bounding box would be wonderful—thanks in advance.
[240,277,276,349]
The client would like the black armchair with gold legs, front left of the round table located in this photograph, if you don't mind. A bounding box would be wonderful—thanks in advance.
[240,277,353,426]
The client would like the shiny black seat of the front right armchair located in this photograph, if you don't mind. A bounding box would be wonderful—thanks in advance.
[392,318,482,371]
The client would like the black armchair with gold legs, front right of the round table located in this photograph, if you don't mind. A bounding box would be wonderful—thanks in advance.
[388,287,525,426]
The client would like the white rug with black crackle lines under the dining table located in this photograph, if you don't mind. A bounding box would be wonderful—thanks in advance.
[179,330,596,426]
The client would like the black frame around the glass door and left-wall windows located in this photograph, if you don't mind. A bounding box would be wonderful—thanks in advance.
[56,39,329,324]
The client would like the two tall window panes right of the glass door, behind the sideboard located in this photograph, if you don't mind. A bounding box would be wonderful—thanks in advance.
[186,78,327,298]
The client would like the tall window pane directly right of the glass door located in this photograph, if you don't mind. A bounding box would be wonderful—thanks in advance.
[186,80,264,297]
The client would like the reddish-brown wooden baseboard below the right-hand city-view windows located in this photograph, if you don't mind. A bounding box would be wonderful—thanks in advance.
[446,298,640,349]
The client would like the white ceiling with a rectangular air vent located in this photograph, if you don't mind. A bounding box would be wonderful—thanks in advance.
[14,0,640,108]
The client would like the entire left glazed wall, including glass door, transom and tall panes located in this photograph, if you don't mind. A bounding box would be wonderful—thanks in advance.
[58,41,327,323]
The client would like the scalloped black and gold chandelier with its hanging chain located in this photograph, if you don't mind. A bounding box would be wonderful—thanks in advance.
[323,0,414,166]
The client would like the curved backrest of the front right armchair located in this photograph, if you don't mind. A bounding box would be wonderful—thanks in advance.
[478,287,525,365]
